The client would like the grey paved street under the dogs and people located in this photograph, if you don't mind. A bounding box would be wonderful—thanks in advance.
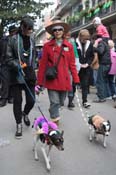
[0,89,116,175]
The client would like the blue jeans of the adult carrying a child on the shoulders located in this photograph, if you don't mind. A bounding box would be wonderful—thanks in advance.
[96,65,110,99]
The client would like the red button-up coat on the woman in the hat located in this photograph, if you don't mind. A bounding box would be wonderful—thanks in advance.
[37,39,79,91]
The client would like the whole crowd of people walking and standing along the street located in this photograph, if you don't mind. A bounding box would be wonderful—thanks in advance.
[0,17,116,138]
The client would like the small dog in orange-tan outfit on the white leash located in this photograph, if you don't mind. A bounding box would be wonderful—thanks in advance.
[88,115,111,147]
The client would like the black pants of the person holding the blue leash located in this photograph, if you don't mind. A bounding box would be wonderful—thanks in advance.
[13,84,35,124]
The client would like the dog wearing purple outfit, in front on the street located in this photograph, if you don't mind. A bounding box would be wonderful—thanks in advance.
[33,116,64,170]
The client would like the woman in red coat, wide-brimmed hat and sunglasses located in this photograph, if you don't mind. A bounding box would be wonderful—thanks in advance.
[37,20,79,124]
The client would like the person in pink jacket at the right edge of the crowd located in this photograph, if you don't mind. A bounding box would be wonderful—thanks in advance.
[108,40,116,99]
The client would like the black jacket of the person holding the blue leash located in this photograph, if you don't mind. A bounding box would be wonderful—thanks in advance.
[6,34,36,84]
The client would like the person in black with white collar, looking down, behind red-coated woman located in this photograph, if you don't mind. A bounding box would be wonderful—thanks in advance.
[76,29,94,108]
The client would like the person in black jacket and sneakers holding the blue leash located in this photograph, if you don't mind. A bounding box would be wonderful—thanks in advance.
[6,17,36,138]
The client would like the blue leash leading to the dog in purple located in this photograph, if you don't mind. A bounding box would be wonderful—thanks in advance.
[18,65,48,123]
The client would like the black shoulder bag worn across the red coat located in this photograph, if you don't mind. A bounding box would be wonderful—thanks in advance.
[46,46,63,80]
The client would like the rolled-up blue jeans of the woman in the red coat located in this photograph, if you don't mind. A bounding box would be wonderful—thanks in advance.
[48,89,67,119]
